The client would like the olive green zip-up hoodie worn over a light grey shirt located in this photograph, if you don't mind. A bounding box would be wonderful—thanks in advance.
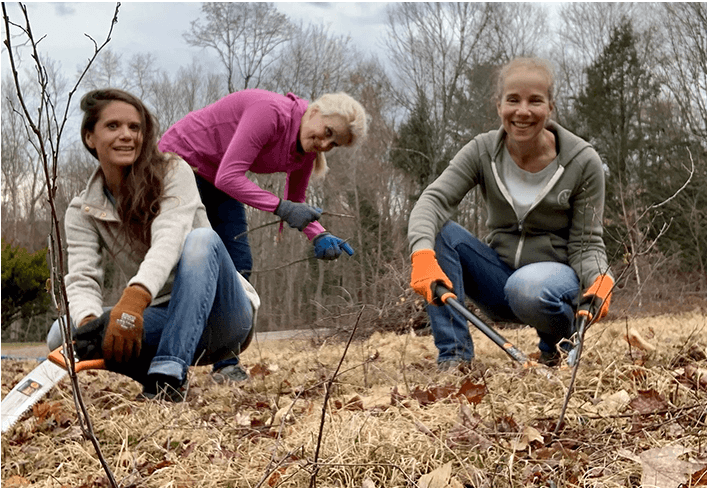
[408,122,610,289]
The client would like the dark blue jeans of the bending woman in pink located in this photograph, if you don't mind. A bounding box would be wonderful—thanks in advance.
[195,174,253,371]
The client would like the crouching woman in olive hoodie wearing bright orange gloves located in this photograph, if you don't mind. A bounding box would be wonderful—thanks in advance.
[408,58,613,370]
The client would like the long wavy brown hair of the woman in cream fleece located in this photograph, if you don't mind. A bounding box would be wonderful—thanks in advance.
[80,88,168,248]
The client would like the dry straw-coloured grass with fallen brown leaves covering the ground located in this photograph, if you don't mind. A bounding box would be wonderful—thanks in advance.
[2,312,707,487]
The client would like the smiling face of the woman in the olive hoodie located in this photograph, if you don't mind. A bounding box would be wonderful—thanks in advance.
[497,66,553,143]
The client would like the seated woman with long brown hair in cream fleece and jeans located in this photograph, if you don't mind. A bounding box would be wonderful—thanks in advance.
[47,89,259,401]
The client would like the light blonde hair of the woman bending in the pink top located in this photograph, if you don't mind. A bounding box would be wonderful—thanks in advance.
[310,92,367,178]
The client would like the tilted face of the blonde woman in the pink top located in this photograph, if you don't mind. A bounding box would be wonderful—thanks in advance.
[298,108,352,153]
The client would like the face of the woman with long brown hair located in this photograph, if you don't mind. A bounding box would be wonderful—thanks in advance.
[85,100,143,175]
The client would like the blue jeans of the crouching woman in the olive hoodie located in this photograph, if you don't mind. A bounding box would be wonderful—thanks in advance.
[426,221,580,363]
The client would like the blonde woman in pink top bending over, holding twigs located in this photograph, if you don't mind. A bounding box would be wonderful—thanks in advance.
[159,89,367,381]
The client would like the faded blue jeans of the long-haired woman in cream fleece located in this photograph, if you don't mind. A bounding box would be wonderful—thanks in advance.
[47,228,253,384]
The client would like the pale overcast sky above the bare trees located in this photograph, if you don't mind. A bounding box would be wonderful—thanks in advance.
[2,2,386,81]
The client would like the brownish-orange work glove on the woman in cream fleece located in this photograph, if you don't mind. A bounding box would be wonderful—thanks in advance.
[103,285,151,363]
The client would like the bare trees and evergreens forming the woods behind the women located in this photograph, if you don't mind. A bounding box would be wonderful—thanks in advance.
[2,2,707,341]
